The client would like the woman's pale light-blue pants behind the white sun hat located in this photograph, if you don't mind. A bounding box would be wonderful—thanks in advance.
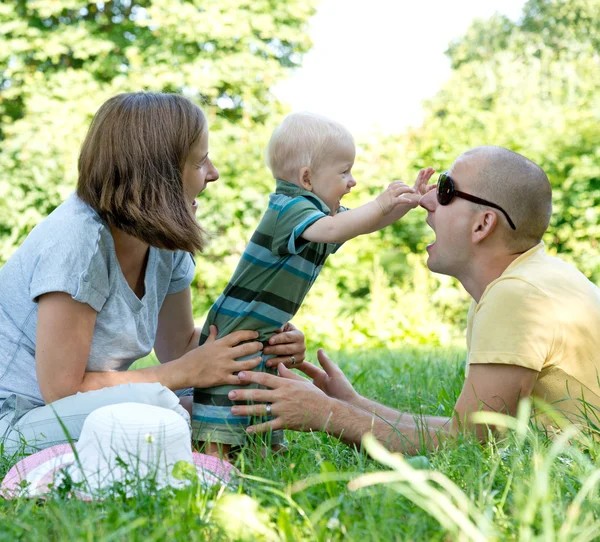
[0,383,192,455]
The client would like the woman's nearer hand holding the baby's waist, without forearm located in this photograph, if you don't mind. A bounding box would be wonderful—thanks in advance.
[170,326,262,389]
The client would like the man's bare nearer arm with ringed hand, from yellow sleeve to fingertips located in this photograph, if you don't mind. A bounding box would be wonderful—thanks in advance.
[229,356,538,455]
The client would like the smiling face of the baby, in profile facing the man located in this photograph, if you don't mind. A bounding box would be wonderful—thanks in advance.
[312,145,356,216]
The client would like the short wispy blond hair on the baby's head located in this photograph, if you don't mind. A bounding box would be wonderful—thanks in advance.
[266,113,354,182]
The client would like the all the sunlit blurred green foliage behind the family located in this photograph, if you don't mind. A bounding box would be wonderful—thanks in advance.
[0,0,600,348]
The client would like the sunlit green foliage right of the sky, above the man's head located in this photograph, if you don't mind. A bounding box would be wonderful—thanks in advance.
[406,0,600,283]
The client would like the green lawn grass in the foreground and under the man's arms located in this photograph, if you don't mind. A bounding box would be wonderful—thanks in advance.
[0,349,600,542]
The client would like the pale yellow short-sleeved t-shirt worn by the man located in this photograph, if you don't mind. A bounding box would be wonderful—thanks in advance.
[467,243,600,428]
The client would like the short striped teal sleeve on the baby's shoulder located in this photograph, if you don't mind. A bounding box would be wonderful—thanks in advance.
[272,197,327,256]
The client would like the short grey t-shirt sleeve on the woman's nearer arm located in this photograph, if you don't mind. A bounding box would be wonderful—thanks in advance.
[29,234,110,312]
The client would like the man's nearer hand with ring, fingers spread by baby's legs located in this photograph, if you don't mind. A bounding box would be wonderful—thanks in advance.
[229,364,336,433]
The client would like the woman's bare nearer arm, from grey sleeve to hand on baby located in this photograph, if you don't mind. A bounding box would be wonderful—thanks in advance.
[35,292,262,403]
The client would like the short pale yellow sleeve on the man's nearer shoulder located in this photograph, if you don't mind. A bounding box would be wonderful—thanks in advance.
[469,278,559,371]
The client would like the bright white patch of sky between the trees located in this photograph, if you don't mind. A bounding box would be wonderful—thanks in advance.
[274,0,525,136]
